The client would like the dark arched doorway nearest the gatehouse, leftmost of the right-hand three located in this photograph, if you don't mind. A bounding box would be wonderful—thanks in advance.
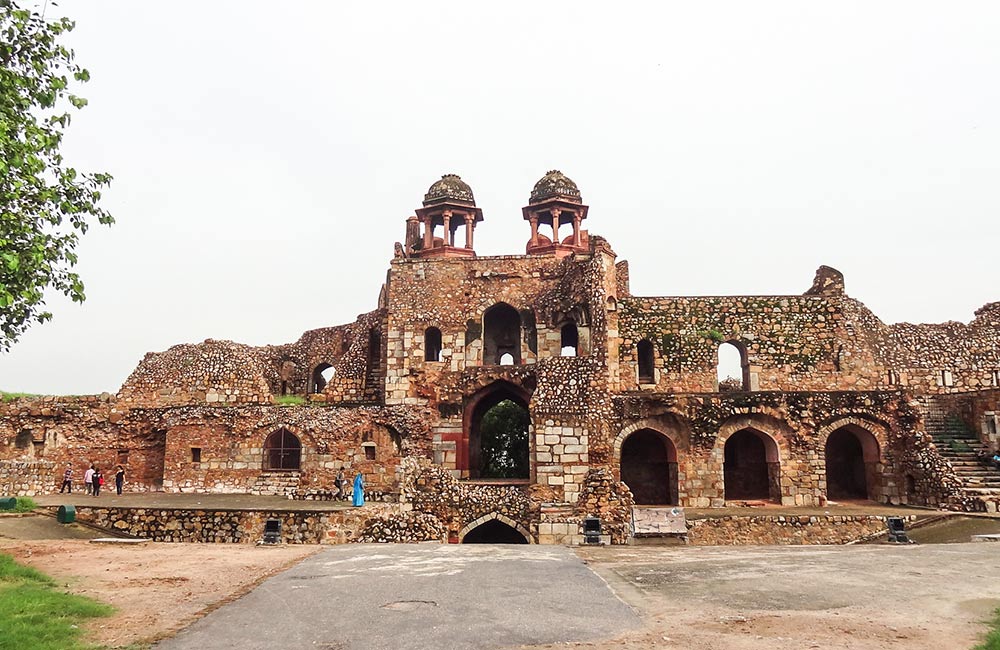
[621,429,677,505]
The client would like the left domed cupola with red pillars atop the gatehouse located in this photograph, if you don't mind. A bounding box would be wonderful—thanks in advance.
[407,174,483,257]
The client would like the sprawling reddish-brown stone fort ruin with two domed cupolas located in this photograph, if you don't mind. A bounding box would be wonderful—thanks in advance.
[0,171,1000,543]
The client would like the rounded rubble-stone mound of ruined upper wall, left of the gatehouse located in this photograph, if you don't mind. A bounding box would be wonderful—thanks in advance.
[118,339,271,406]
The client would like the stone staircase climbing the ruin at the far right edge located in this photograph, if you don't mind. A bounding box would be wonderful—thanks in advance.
[924,398,1000,497]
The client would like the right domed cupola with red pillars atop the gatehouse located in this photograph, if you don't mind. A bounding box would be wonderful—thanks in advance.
[522,169,589,257]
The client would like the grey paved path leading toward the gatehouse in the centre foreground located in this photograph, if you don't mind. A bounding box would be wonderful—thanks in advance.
[156,544,640,650]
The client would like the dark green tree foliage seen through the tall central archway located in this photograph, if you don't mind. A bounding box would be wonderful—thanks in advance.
[479,399,530,478]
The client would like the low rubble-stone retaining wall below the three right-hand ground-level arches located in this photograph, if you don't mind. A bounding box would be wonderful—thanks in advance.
[688,515,916,546]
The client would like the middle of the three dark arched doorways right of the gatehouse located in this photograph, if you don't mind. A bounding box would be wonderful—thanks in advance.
[723,429,781,501]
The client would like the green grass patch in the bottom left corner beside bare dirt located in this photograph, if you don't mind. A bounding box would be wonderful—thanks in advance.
[0,553,114,650]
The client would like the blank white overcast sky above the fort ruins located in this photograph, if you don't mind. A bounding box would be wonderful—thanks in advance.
[0,0,1000,394]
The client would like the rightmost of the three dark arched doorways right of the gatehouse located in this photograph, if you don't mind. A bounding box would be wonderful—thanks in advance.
[825,425,879,499]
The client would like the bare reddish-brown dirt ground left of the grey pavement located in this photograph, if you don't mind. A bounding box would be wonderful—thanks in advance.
[0,540,321,646]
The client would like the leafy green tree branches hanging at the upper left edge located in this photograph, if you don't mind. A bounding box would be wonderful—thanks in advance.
[0,0,114,351]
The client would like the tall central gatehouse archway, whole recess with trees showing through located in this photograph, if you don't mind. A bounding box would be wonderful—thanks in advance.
[459,381,531,479]
